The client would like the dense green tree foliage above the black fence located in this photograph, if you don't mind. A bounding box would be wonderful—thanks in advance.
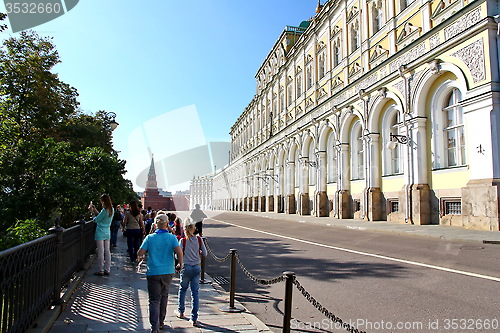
[0,32,136,248]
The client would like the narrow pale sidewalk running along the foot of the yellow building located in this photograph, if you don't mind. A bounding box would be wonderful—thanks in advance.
[226,211,500,243]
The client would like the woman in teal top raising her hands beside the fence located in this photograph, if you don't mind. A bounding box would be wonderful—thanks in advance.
[89,194,114,276]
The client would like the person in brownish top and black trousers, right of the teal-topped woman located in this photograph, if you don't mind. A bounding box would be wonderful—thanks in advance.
[123,200,145,263]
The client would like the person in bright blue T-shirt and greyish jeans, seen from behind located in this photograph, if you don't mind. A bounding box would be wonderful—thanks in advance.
[137,214,183,333]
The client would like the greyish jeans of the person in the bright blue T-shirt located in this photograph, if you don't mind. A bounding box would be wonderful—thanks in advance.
[146,274,174,331]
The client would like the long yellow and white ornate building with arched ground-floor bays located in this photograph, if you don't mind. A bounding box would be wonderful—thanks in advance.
[213,0,500,230]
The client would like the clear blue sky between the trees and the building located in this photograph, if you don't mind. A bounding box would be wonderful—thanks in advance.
[0,0,316,190]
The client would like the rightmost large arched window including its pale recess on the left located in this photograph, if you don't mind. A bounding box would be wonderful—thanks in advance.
[432,85,467,169]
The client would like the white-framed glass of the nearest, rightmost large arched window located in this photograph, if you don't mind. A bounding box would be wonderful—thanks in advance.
[443,88,466,167]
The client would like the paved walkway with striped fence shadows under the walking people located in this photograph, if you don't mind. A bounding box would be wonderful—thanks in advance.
[49,236,271,333]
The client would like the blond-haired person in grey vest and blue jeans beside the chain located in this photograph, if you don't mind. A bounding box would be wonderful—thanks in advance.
[175,217,207,326]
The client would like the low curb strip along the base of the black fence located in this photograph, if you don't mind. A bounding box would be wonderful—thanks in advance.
[26,254,97,333]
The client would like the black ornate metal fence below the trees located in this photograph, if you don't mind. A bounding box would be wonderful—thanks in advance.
[0,221,95,333]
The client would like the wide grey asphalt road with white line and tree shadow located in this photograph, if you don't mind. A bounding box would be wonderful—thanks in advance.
[199,213,500,332]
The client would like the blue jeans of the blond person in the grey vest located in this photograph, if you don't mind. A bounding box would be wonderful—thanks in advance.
[177,265,201,321]
